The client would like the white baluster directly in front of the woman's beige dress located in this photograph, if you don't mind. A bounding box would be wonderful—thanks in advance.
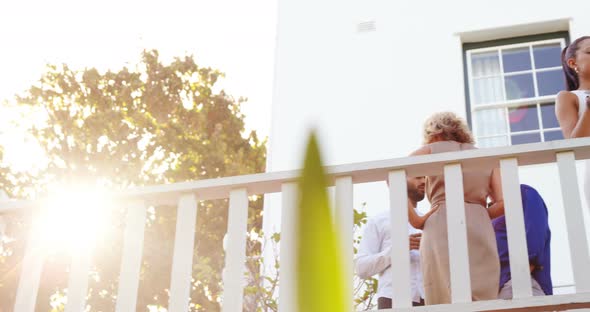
[444,164,471,303]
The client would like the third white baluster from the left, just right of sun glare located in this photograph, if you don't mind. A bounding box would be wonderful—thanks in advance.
[115,200,146,312]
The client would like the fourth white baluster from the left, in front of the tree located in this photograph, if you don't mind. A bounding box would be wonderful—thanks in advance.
[168,195,197,311]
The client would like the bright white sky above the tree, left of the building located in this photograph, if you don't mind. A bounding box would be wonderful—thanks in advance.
[0,0,276,137]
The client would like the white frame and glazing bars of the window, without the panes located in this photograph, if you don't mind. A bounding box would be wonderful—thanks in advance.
[465,38,566,146]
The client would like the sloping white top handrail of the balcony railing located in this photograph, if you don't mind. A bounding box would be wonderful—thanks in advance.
[0,138,590,213]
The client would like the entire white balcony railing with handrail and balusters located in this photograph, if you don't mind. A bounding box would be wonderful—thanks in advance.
[0,138,590,312]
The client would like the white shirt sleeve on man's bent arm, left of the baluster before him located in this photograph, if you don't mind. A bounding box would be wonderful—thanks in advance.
[354,219,391,278]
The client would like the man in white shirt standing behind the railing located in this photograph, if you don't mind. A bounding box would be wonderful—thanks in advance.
[354,177,425,309]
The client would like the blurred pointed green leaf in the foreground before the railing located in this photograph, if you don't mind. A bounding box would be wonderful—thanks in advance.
[296,134,352,312]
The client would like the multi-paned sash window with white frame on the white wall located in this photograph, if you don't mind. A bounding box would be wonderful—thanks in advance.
[464,32,567,147]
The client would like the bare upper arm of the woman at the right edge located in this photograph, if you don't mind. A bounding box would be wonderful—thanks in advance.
[555,91,590,139]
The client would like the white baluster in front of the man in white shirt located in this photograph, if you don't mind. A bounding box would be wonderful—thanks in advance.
[389,170,412,308]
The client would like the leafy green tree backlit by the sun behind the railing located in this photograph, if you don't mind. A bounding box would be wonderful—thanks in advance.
[0,51,266,311]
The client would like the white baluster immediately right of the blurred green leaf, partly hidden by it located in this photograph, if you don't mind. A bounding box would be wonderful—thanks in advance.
[335,176,354,312]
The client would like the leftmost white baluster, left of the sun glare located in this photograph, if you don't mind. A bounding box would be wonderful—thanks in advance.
[14,210,45,312]
